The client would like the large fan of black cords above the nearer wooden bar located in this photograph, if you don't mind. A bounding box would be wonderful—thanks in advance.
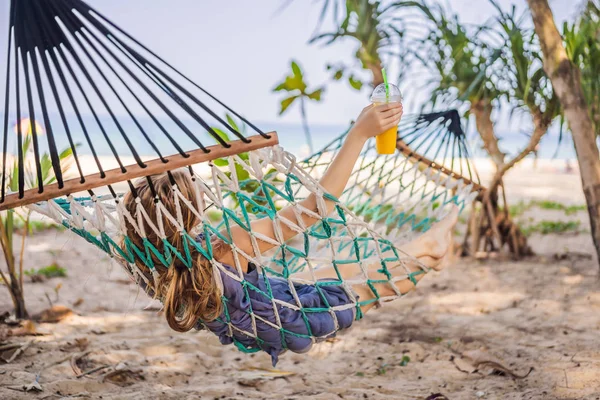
[0,0,269,203]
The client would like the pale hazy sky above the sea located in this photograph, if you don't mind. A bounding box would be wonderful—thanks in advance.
[0,0,578,131]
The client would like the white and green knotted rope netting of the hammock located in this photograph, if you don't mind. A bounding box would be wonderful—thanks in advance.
[34,132,469,360]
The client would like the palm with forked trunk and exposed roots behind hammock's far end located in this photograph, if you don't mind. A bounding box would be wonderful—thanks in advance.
[410,0,561,256]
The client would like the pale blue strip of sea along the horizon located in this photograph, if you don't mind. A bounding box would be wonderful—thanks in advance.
[0,114,576,160]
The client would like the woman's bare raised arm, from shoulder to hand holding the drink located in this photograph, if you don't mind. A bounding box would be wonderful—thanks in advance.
[219,103,402,269]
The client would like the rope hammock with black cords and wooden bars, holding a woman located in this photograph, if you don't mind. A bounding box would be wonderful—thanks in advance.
[0,0,483,360]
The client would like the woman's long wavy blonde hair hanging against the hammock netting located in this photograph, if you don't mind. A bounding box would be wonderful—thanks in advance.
[124,169,226,332]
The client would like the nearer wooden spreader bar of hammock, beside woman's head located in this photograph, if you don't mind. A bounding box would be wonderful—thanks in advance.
[0,132,279,211]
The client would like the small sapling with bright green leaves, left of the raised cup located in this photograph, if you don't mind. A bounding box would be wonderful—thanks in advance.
[273,61,325,154]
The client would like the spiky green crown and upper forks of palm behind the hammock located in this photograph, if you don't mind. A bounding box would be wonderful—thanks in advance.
[410,0,562,169]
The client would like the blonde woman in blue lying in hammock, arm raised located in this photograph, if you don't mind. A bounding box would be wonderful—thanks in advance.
[125,104,458,364]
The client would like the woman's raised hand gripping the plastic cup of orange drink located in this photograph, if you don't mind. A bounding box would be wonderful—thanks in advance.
[348,103,402,141]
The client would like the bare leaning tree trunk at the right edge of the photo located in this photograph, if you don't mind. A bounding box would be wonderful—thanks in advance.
[527,0,600,266]
